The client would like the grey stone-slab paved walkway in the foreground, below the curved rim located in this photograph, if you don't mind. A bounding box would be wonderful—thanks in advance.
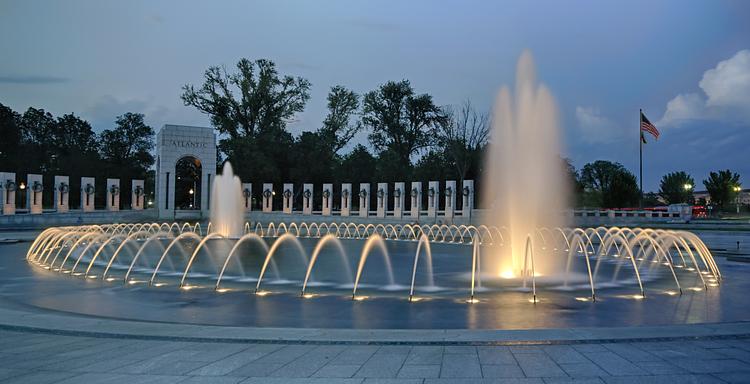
[0,331,750,384]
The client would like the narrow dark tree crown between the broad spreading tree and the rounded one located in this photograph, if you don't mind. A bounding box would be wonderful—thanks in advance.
[320,85,362,153]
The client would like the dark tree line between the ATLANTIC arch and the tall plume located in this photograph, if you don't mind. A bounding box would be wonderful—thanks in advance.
[182,59,489,208]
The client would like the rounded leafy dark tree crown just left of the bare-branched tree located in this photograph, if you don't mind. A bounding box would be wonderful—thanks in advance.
[362,80,445,172]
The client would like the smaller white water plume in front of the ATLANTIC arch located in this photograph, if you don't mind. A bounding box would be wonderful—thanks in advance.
[211,161,245,239]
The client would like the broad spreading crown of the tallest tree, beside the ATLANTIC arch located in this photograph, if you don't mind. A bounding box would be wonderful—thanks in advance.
[182,58,310,139]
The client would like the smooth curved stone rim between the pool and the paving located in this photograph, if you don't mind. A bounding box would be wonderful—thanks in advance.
[0,308,750,345]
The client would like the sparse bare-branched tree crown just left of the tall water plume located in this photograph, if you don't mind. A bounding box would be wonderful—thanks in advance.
[437,100,490,181]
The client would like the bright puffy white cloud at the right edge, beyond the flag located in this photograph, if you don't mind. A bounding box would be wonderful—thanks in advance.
[657,49,750,126]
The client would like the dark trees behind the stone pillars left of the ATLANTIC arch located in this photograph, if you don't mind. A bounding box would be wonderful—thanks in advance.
[0,104,154,208]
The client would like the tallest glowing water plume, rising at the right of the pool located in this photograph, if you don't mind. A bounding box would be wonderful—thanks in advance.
[483,51,568,276]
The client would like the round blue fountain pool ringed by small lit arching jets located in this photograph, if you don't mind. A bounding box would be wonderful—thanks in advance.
[8,222,750,329]
